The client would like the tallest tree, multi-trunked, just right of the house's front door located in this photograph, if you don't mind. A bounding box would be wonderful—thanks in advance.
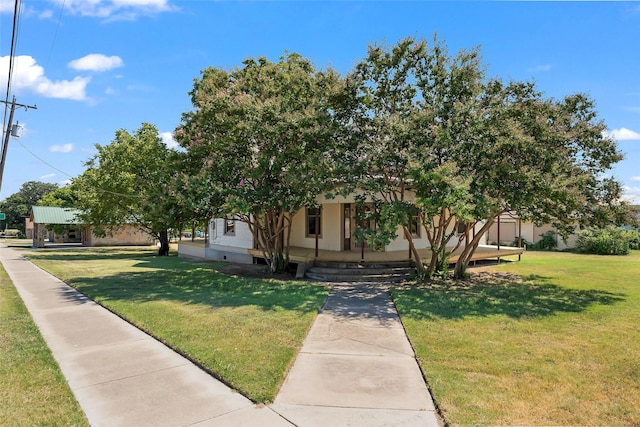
[341,38,483,274]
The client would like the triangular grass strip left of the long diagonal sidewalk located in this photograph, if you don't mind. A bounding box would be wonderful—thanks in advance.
[0,264,88,426]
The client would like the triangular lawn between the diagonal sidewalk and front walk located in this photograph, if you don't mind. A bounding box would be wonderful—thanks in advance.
[25,249,328,402]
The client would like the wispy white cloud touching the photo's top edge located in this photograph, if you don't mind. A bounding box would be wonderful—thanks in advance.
[53,0,176,20]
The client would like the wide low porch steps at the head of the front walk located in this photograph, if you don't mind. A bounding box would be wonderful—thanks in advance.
[305,261,414,282]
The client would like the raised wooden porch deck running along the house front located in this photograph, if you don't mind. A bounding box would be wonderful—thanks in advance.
[249,245,526,263]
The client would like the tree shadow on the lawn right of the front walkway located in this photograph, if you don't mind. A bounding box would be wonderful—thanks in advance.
[392,274,625,320]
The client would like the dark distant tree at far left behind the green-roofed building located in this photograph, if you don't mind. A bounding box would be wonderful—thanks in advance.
[0,181,58,234]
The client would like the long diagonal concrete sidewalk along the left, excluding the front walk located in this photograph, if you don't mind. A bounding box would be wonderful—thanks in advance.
[0,247,291,427]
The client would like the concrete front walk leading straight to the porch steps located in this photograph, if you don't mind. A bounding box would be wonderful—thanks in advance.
[271,284,439,427]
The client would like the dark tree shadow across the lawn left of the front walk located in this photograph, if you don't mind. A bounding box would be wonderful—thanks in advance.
[52,257,328,314]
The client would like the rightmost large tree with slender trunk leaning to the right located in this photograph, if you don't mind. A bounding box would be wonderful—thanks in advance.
[455,80,622,277]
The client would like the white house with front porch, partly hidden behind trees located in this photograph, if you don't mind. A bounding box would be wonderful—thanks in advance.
[178,196,523,263]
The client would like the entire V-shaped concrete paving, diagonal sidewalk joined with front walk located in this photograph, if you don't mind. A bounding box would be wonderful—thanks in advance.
[0,246,438,427]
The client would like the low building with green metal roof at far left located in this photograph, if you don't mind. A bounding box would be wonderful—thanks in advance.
[30,206,153,248]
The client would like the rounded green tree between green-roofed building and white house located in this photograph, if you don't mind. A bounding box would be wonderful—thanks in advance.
[73,123,183,255]
